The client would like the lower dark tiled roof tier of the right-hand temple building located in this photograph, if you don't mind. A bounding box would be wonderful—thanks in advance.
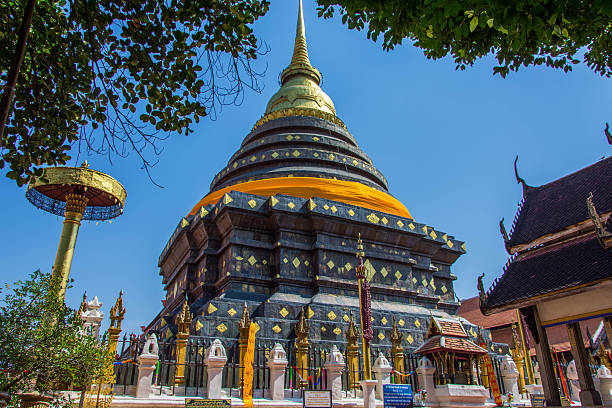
[482,234,612,314]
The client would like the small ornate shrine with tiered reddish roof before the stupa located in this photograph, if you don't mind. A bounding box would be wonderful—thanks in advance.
[415,316,487,385]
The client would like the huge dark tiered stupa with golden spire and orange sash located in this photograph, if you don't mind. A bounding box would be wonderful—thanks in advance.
[146,1,477,350]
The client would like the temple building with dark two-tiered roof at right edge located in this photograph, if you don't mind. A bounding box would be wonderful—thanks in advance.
[479,157,612,406]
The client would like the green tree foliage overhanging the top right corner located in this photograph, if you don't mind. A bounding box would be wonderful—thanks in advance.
[318,0,612,77]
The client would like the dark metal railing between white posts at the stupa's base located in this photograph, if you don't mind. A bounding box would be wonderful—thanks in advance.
[115,336,420,397]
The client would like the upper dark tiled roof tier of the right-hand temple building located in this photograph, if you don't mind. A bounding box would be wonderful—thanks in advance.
[507,157,612,248]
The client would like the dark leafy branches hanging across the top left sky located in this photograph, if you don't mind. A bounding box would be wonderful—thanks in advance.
[0,0,269,185]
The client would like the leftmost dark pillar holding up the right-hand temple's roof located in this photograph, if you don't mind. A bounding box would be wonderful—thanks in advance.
[524,306,561,406]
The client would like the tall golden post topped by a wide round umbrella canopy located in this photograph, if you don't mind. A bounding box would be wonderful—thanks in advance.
[26,162,126,299]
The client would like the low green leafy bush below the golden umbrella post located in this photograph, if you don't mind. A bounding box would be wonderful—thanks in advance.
[0,271,114,400]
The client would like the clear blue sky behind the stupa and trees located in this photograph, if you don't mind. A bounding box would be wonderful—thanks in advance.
[0,0,612,333]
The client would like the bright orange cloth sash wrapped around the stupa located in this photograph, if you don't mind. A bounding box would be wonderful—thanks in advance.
[189,177,412,218]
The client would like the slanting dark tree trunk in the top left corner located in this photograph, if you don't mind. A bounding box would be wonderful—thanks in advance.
[0,0,36,146]
